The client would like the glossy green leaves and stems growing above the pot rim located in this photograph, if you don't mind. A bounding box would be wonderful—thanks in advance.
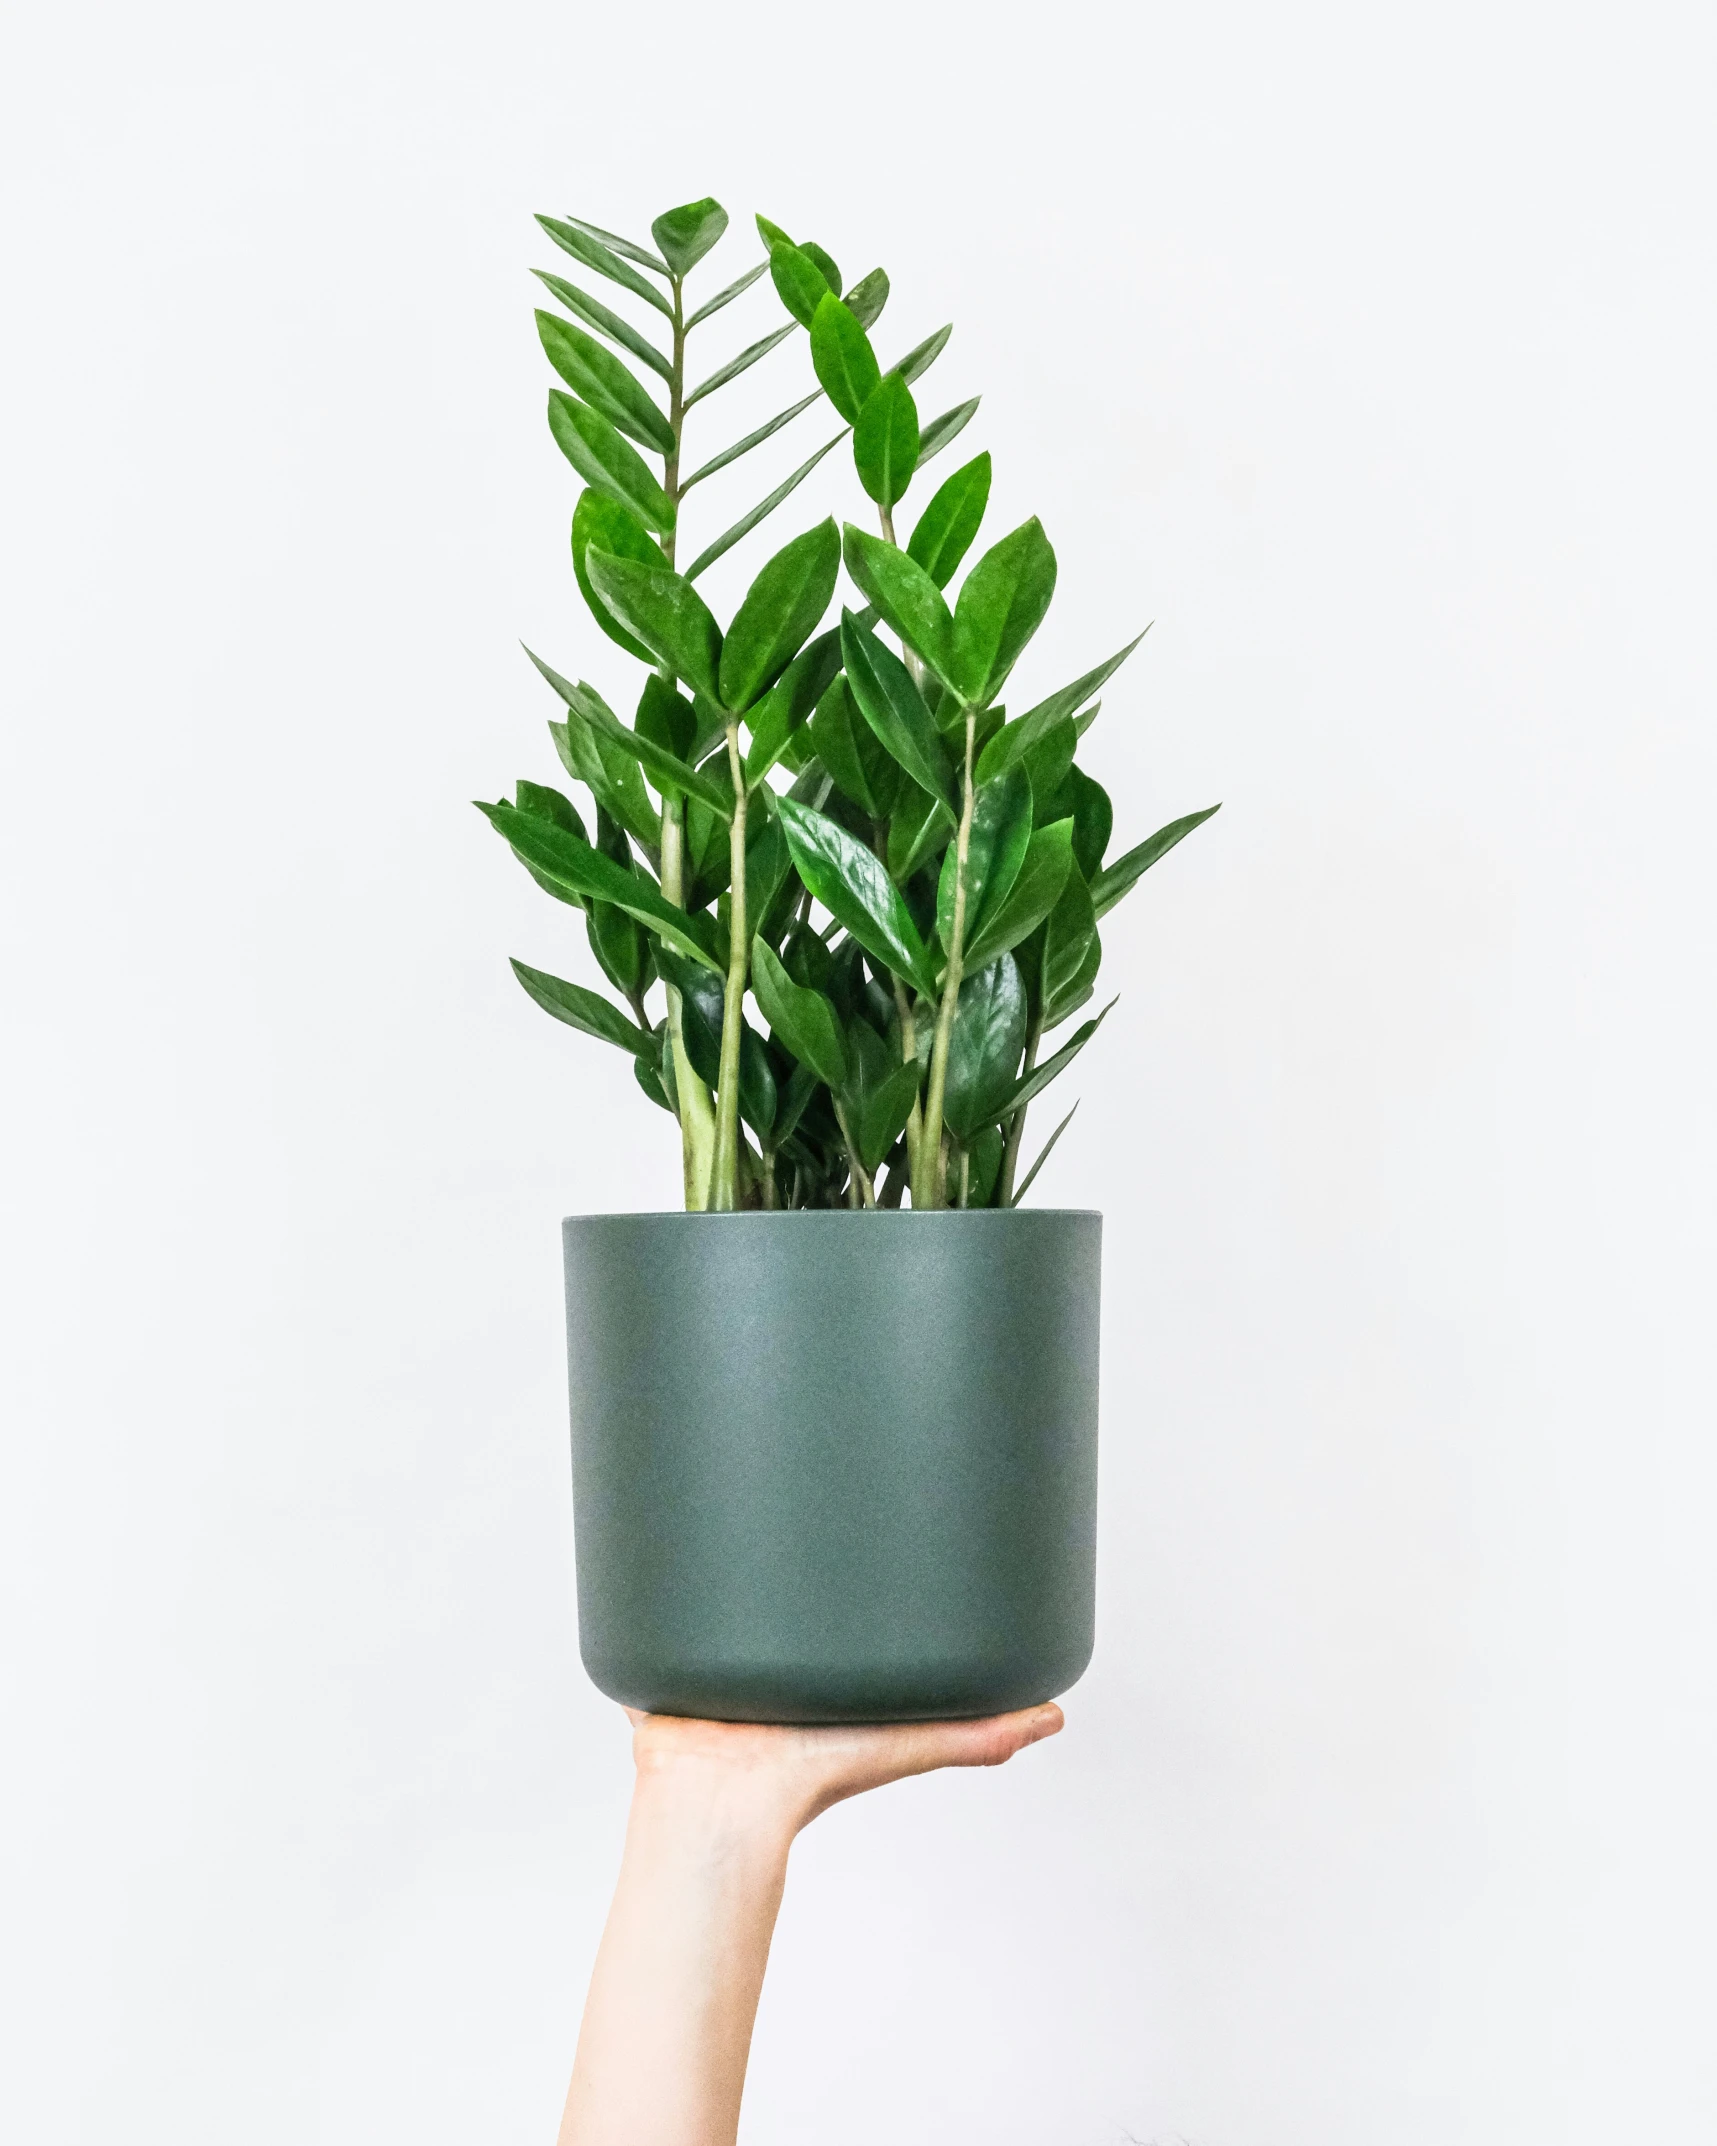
[479,200,1217,1208]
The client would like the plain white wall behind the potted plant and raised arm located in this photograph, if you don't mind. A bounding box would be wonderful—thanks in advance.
[0,0,1717,2146]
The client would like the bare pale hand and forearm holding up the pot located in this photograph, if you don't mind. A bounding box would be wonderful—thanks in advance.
[558,1706,1062,2146]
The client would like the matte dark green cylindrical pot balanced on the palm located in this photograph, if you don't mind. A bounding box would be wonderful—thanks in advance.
[564,1208,1103,1721]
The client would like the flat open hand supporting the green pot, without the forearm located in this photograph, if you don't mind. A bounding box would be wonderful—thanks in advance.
[627,1702,1062,1837]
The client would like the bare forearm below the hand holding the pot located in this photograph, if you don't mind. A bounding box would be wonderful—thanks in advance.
[560,1766,794,2146]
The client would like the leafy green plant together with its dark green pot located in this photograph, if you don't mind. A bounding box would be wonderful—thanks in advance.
[479,200,1215,1721]
